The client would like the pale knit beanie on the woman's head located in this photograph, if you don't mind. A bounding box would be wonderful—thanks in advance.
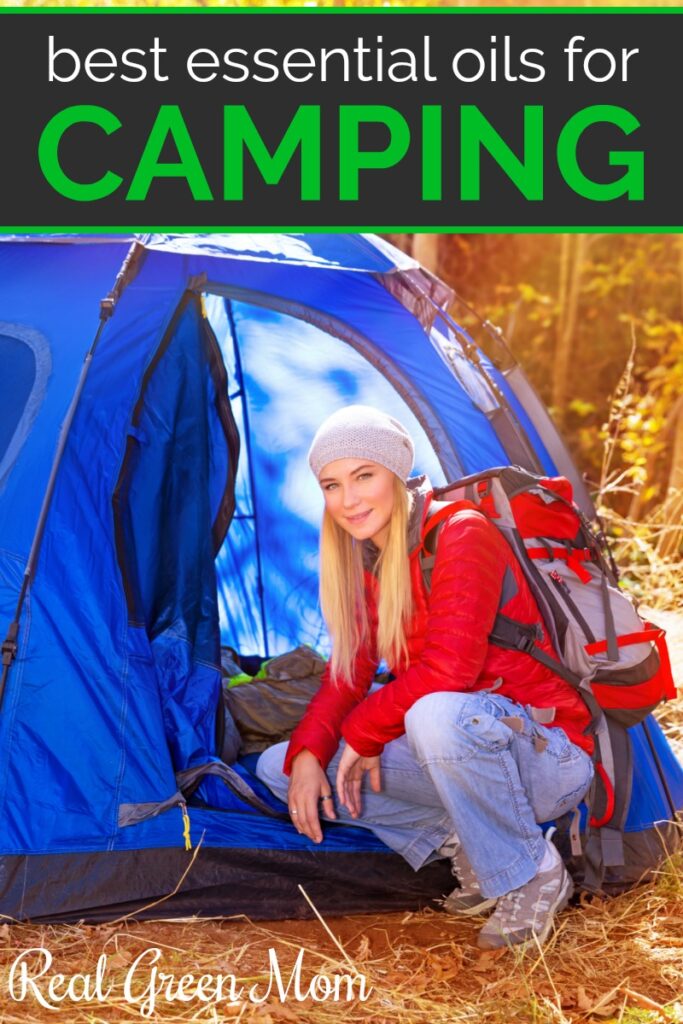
[308,406,415,483]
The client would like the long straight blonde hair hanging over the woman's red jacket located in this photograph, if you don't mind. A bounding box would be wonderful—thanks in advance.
[321,476,413,683]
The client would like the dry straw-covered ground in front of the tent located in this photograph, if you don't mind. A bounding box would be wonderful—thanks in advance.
[0,864,683,1024]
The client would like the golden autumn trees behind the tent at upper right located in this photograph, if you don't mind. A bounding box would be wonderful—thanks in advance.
[390,233,683,581]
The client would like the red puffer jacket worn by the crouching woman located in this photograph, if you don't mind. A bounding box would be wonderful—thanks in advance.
[285,495,593,774]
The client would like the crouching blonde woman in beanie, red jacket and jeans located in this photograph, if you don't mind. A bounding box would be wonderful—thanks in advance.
[257,406,593,949]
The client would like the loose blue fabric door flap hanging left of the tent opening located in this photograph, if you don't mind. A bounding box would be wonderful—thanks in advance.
[113,292,240,772]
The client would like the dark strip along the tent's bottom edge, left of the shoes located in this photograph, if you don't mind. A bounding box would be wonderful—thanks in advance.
[0,847,455,924]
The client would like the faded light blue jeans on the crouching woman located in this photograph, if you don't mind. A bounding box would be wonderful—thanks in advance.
[256,691,593,897]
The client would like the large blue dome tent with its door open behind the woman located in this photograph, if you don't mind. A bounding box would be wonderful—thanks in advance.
[0,234,683,921]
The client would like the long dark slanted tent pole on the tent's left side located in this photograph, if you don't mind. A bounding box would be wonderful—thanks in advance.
[0,242,144,708]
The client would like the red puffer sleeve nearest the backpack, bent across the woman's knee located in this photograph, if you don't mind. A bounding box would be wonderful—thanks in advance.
[342,510,506,757]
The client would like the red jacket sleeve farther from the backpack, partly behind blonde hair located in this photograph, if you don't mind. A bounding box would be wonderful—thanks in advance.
[283,581,377,775]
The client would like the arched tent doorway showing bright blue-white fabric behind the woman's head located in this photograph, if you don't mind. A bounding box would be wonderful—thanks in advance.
[205,286,452,658]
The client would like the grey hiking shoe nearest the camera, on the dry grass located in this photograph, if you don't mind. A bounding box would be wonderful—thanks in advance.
[477,841,573,949]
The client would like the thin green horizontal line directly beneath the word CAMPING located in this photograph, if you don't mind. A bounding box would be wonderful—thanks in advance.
[0,224,683,234]
